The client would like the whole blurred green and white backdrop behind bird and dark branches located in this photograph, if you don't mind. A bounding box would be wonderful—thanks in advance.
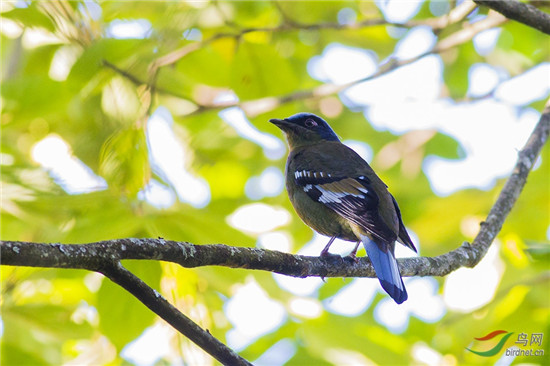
[0,0,550,365]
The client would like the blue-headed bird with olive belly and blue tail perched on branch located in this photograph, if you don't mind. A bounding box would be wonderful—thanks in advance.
[269,113,416,304]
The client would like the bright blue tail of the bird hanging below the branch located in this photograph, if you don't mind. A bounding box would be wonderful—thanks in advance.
[361,235,408,304]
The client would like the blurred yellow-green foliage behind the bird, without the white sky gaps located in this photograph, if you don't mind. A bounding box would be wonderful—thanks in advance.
[0,1,550,365]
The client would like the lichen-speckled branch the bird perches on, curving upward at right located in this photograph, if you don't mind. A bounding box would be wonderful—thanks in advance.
[0,101,550,277]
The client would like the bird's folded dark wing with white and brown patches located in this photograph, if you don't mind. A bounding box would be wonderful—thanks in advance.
[294,170,397,243]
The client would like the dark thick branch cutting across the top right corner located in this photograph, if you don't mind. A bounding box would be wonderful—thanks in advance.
[474,0,550,34]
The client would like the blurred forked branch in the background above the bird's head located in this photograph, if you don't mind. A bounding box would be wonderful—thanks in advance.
[103,0,488,117]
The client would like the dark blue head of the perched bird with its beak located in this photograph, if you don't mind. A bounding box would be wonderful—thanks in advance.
[269,113,340,149]
